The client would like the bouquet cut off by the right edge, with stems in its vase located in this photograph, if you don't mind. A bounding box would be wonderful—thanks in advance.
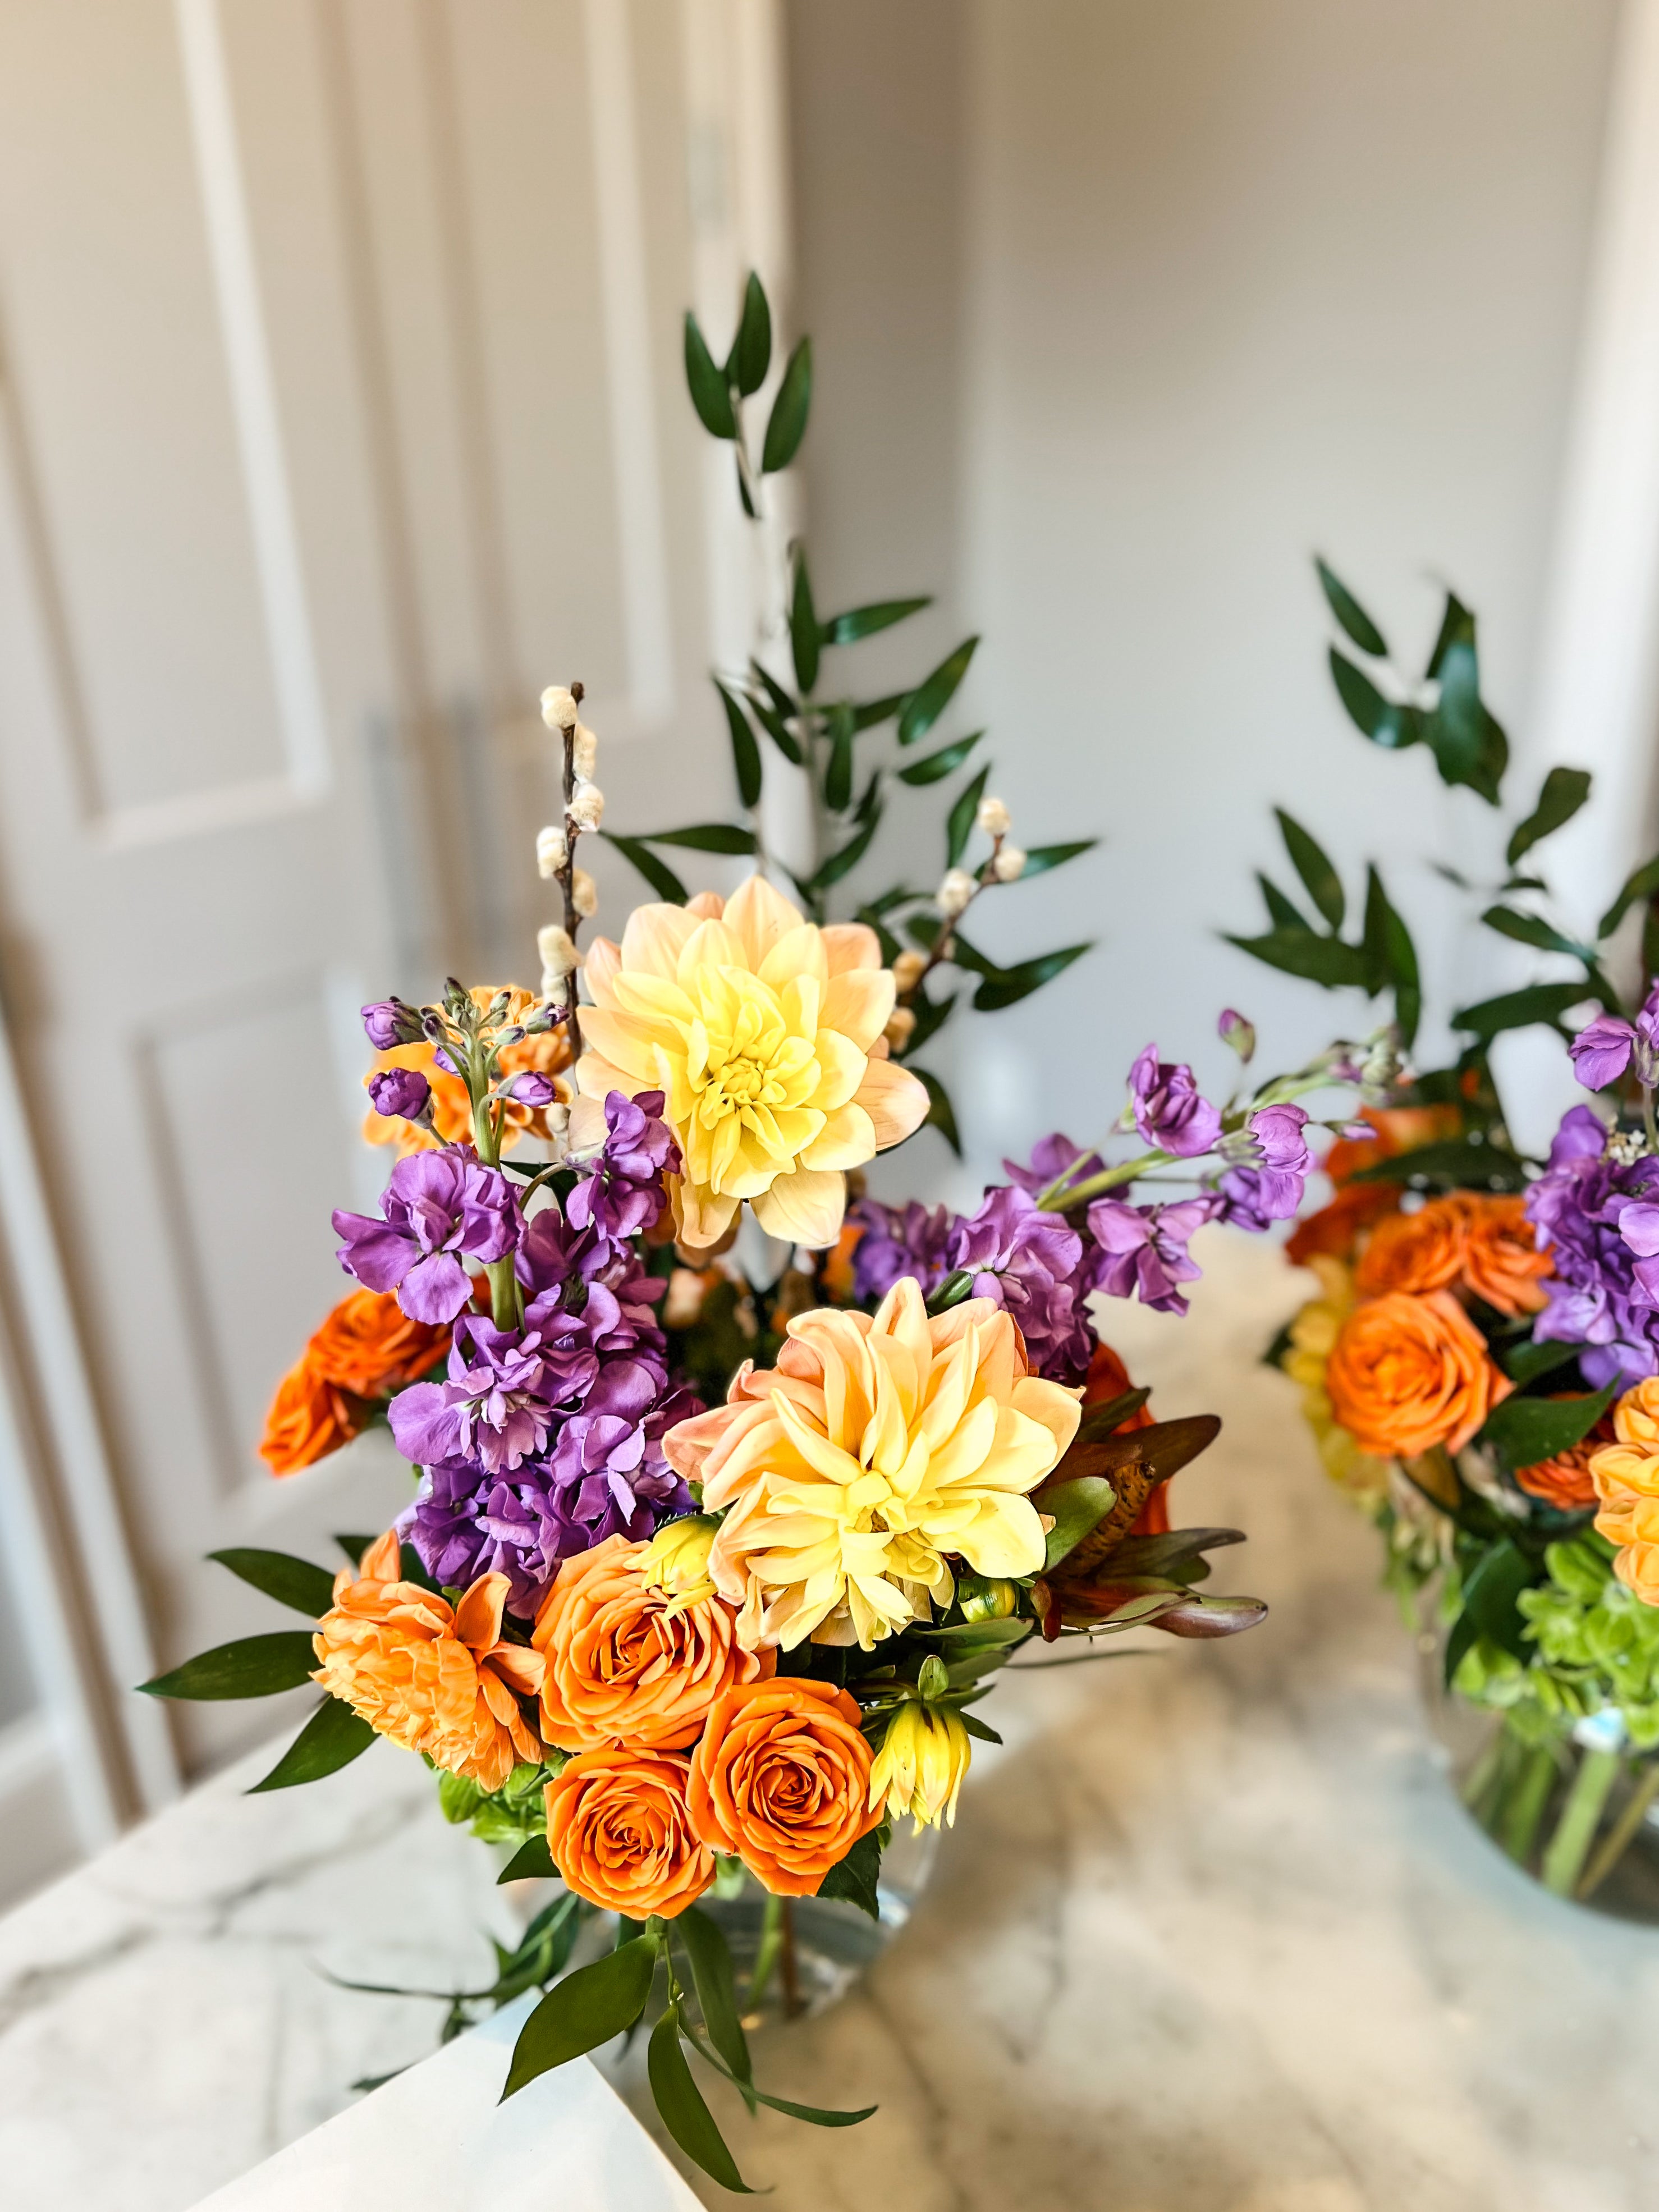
[1232,562,1659,1918]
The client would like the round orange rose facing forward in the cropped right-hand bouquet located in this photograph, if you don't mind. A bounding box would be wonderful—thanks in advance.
[1325,1290,1515,1460]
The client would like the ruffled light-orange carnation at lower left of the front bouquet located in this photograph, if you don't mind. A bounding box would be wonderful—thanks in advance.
[312,1528,544,1789]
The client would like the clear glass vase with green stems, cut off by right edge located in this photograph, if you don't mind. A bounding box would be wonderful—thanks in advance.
[1420,1631,1659,1927]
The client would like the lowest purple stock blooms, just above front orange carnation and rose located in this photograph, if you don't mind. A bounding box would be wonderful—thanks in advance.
[398,1391,701,1619]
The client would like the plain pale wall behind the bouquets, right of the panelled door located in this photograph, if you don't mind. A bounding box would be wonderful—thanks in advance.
[790,0,1617,1179]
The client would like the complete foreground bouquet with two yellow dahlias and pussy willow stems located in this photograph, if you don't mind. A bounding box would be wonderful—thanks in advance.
[146,281,1300,2188]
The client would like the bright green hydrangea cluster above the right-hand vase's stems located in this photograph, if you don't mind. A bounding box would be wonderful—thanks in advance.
[1453,1537,1659,1752]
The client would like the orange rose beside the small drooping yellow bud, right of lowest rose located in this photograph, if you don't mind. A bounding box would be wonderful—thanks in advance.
[686,1674,881,1898]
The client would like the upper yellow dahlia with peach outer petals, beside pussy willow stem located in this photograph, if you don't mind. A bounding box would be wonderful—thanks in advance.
[575,876,927,1250]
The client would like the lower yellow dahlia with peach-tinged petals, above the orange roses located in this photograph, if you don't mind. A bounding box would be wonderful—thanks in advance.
[663,1276,1079,1650]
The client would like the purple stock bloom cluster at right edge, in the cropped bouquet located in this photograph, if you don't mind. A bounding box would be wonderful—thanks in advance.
[1527,1106,1659,1389]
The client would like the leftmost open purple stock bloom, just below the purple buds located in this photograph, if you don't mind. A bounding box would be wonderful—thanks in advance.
[334,1143,520,1323]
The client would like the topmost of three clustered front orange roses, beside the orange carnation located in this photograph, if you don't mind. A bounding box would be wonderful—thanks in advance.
[531,1535,776,1752]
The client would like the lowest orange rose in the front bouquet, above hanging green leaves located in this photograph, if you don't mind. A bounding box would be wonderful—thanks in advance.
[544,1745,714,1920]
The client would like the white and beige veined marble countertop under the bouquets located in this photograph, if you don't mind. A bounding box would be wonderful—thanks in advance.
[0,1232,1659,2212]
